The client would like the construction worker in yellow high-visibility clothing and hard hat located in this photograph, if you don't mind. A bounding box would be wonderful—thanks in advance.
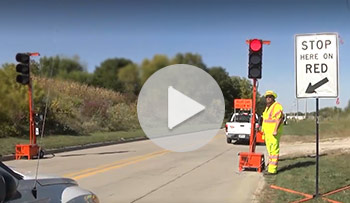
[262,90,284,175]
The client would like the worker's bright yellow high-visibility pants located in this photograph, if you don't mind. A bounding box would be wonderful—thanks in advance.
[265,133,281,173]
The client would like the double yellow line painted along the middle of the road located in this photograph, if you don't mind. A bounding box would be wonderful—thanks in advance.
[63,150,170,180]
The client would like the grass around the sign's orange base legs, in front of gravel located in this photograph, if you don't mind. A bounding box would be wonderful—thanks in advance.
[260,152,350,203]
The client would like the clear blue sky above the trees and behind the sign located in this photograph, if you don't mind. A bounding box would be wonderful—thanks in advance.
[0,0,350,112]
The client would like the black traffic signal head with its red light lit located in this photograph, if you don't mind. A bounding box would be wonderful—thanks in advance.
[248,39,263,79]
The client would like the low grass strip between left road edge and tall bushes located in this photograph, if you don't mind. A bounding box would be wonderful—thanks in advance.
[0,130,145,155]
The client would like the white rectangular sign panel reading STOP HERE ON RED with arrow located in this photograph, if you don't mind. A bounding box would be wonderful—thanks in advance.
[295,33,338,98]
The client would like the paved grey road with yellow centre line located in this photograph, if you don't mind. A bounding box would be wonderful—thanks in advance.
[6,131,265,203]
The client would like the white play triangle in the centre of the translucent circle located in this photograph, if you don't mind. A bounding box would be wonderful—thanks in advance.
[168,86,205,129]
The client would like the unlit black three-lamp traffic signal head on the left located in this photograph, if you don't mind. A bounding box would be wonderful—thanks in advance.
[16,53,30,85]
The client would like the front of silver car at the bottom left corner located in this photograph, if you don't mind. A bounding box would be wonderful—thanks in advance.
[0,161,99,203]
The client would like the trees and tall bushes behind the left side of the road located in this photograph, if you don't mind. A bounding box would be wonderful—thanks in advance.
[0,53,264,155]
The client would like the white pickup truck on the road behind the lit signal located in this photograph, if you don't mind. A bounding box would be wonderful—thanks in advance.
[225,113,259,143]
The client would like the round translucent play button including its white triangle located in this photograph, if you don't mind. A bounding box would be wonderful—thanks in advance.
[137,64,225,152]
